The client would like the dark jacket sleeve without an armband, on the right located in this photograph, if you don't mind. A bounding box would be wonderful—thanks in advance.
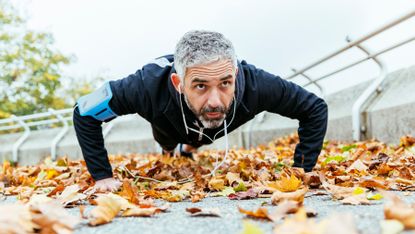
[255,66,328,172]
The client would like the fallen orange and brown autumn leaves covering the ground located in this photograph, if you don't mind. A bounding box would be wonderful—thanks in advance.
[0,135,415,233]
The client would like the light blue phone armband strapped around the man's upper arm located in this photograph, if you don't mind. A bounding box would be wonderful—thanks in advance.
[78,82,117,122]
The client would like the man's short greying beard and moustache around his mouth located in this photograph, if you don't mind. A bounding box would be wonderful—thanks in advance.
[183,95,232,128]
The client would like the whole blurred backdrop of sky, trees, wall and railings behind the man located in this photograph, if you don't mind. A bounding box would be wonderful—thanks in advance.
[0,0,415,164]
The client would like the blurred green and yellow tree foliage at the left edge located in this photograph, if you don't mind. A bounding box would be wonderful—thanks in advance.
[0,0,86,119]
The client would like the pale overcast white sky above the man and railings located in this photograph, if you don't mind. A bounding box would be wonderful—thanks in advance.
[0,0,415,117]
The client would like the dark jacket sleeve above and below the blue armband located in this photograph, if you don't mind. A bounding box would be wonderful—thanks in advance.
[73,70,149,180]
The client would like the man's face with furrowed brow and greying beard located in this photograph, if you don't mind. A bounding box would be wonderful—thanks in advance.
[175,60,237,128]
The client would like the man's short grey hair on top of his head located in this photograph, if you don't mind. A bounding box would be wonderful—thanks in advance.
[174,30,237,81]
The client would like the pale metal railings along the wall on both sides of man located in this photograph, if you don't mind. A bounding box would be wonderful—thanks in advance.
[0,9,415,162]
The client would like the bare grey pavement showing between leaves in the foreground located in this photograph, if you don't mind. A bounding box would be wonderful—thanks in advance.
[0,192,415,234]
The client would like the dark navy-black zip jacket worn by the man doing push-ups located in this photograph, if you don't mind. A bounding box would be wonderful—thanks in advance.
[73,55,327,180]
